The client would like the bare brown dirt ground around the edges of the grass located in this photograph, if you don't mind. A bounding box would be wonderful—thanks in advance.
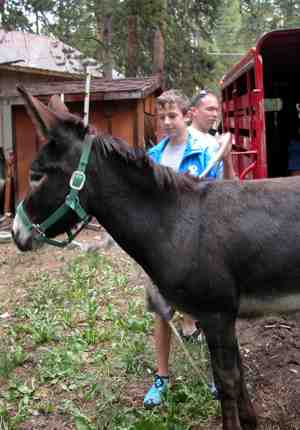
[0,230,300,430]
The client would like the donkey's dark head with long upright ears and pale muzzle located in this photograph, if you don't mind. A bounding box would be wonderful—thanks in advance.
[12,86,89,251]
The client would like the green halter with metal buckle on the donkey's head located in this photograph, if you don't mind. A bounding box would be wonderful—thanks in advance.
[16,135,94,248]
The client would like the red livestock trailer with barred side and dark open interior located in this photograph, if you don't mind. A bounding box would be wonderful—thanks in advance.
[221,28,300,179]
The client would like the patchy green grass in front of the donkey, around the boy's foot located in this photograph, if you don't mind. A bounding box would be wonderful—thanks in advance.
[0,253,219,430]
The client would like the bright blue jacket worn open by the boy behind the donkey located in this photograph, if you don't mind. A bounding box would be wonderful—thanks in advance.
[148,130,223,179]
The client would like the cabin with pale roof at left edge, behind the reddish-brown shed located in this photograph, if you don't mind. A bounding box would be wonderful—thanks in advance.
[0,29,105,217]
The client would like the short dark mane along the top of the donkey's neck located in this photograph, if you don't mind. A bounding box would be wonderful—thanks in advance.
[95,134,200,192]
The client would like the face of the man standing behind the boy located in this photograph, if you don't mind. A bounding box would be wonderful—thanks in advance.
[191,94,220,133]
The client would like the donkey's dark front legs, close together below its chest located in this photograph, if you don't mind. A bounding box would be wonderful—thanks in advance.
[200,313,256,430]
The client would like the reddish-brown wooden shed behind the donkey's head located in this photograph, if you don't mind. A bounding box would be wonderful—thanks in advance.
[0,75,162,212]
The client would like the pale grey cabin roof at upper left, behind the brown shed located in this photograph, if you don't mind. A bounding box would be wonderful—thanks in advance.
[0,30,118,79]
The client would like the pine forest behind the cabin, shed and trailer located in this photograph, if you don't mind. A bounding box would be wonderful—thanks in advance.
[0,0,300,95]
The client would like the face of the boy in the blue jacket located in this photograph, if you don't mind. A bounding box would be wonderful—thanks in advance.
[157,103,187,137]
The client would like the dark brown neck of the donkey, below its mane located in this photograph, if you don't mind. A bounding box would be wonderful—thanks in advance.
[85,151,176,278]
